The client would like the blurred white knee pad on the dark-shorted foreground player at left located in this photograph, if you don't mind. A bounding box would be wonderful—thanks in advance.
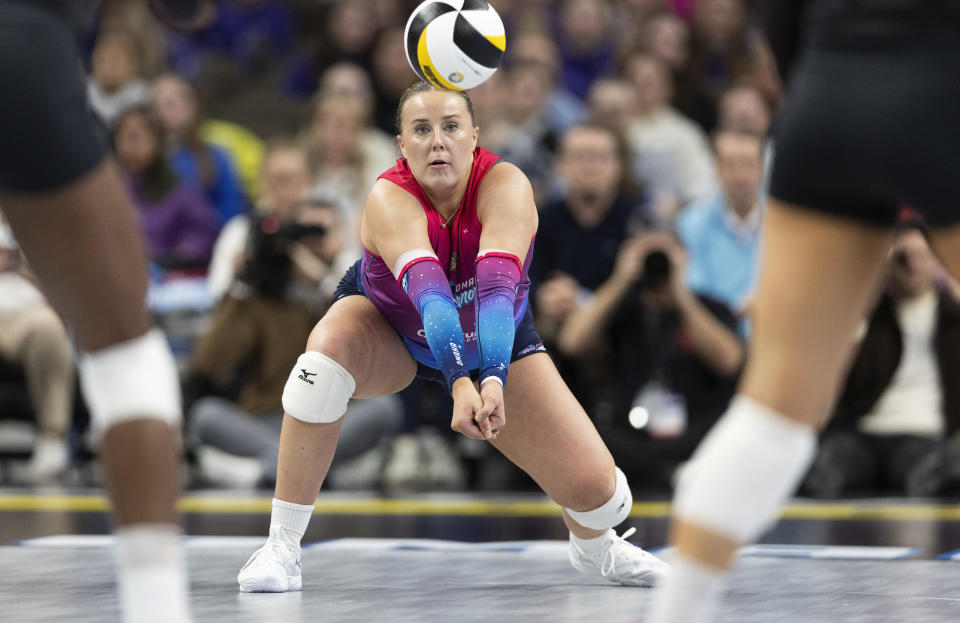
[77,329,183,436]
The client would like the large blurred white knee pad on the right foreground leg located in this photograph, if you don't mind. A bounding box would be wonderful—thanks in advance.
[673,396,816,543]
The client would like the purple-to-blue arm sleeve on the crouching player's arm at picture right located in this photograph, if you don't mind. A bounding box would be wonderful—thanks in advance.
[477,250,523,386]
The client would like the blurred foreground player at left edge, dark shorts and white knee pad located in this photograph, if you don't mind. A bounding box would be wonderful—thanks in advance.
[0,0,212,623]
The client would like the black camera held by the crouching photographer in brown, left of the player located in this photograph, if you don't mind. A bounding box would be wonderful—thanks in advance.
[240,215,327,297]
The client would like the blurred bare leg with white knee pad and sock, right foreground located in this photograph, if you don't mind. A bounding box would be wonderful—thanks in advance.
[650,201,890,623]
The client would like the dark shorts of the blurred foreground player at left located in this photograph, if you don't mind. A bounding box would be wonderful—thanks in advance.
[0,0,108,192]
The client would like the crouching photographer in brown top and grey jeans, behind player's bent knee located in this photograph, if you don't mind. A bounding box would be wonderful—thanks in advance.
[188,197,401,486]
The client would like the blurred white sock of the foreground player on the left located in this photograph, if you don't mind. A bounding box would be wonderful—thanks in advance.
[114,524,190,623]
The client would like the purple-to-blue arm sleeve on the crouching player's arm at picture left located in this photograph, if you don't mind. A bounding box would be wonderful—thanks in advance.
[394,255,470,390]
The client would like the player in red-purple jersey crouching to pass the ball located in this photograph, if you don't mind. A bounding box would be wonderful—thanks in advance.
[238,82,667,592]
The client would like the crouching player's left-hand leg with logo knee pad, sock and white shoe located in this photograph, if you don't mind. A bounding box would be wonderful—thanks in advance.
[237,296,417,592]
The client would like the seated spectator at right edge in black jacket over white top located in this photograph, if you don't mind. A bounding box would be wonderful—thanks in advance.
[804,221,960,498]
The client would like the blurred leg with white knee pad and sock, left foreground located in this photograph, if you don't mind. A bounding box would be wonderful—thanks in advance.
[0,163,189,623]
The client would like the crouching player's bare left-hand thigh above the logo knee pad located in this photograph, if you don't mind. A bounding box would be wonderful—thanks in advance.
[307,295,417,398]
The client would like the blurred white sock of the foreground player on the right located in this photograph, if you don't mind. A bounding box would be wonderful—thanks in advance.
[646,554,726,623]
